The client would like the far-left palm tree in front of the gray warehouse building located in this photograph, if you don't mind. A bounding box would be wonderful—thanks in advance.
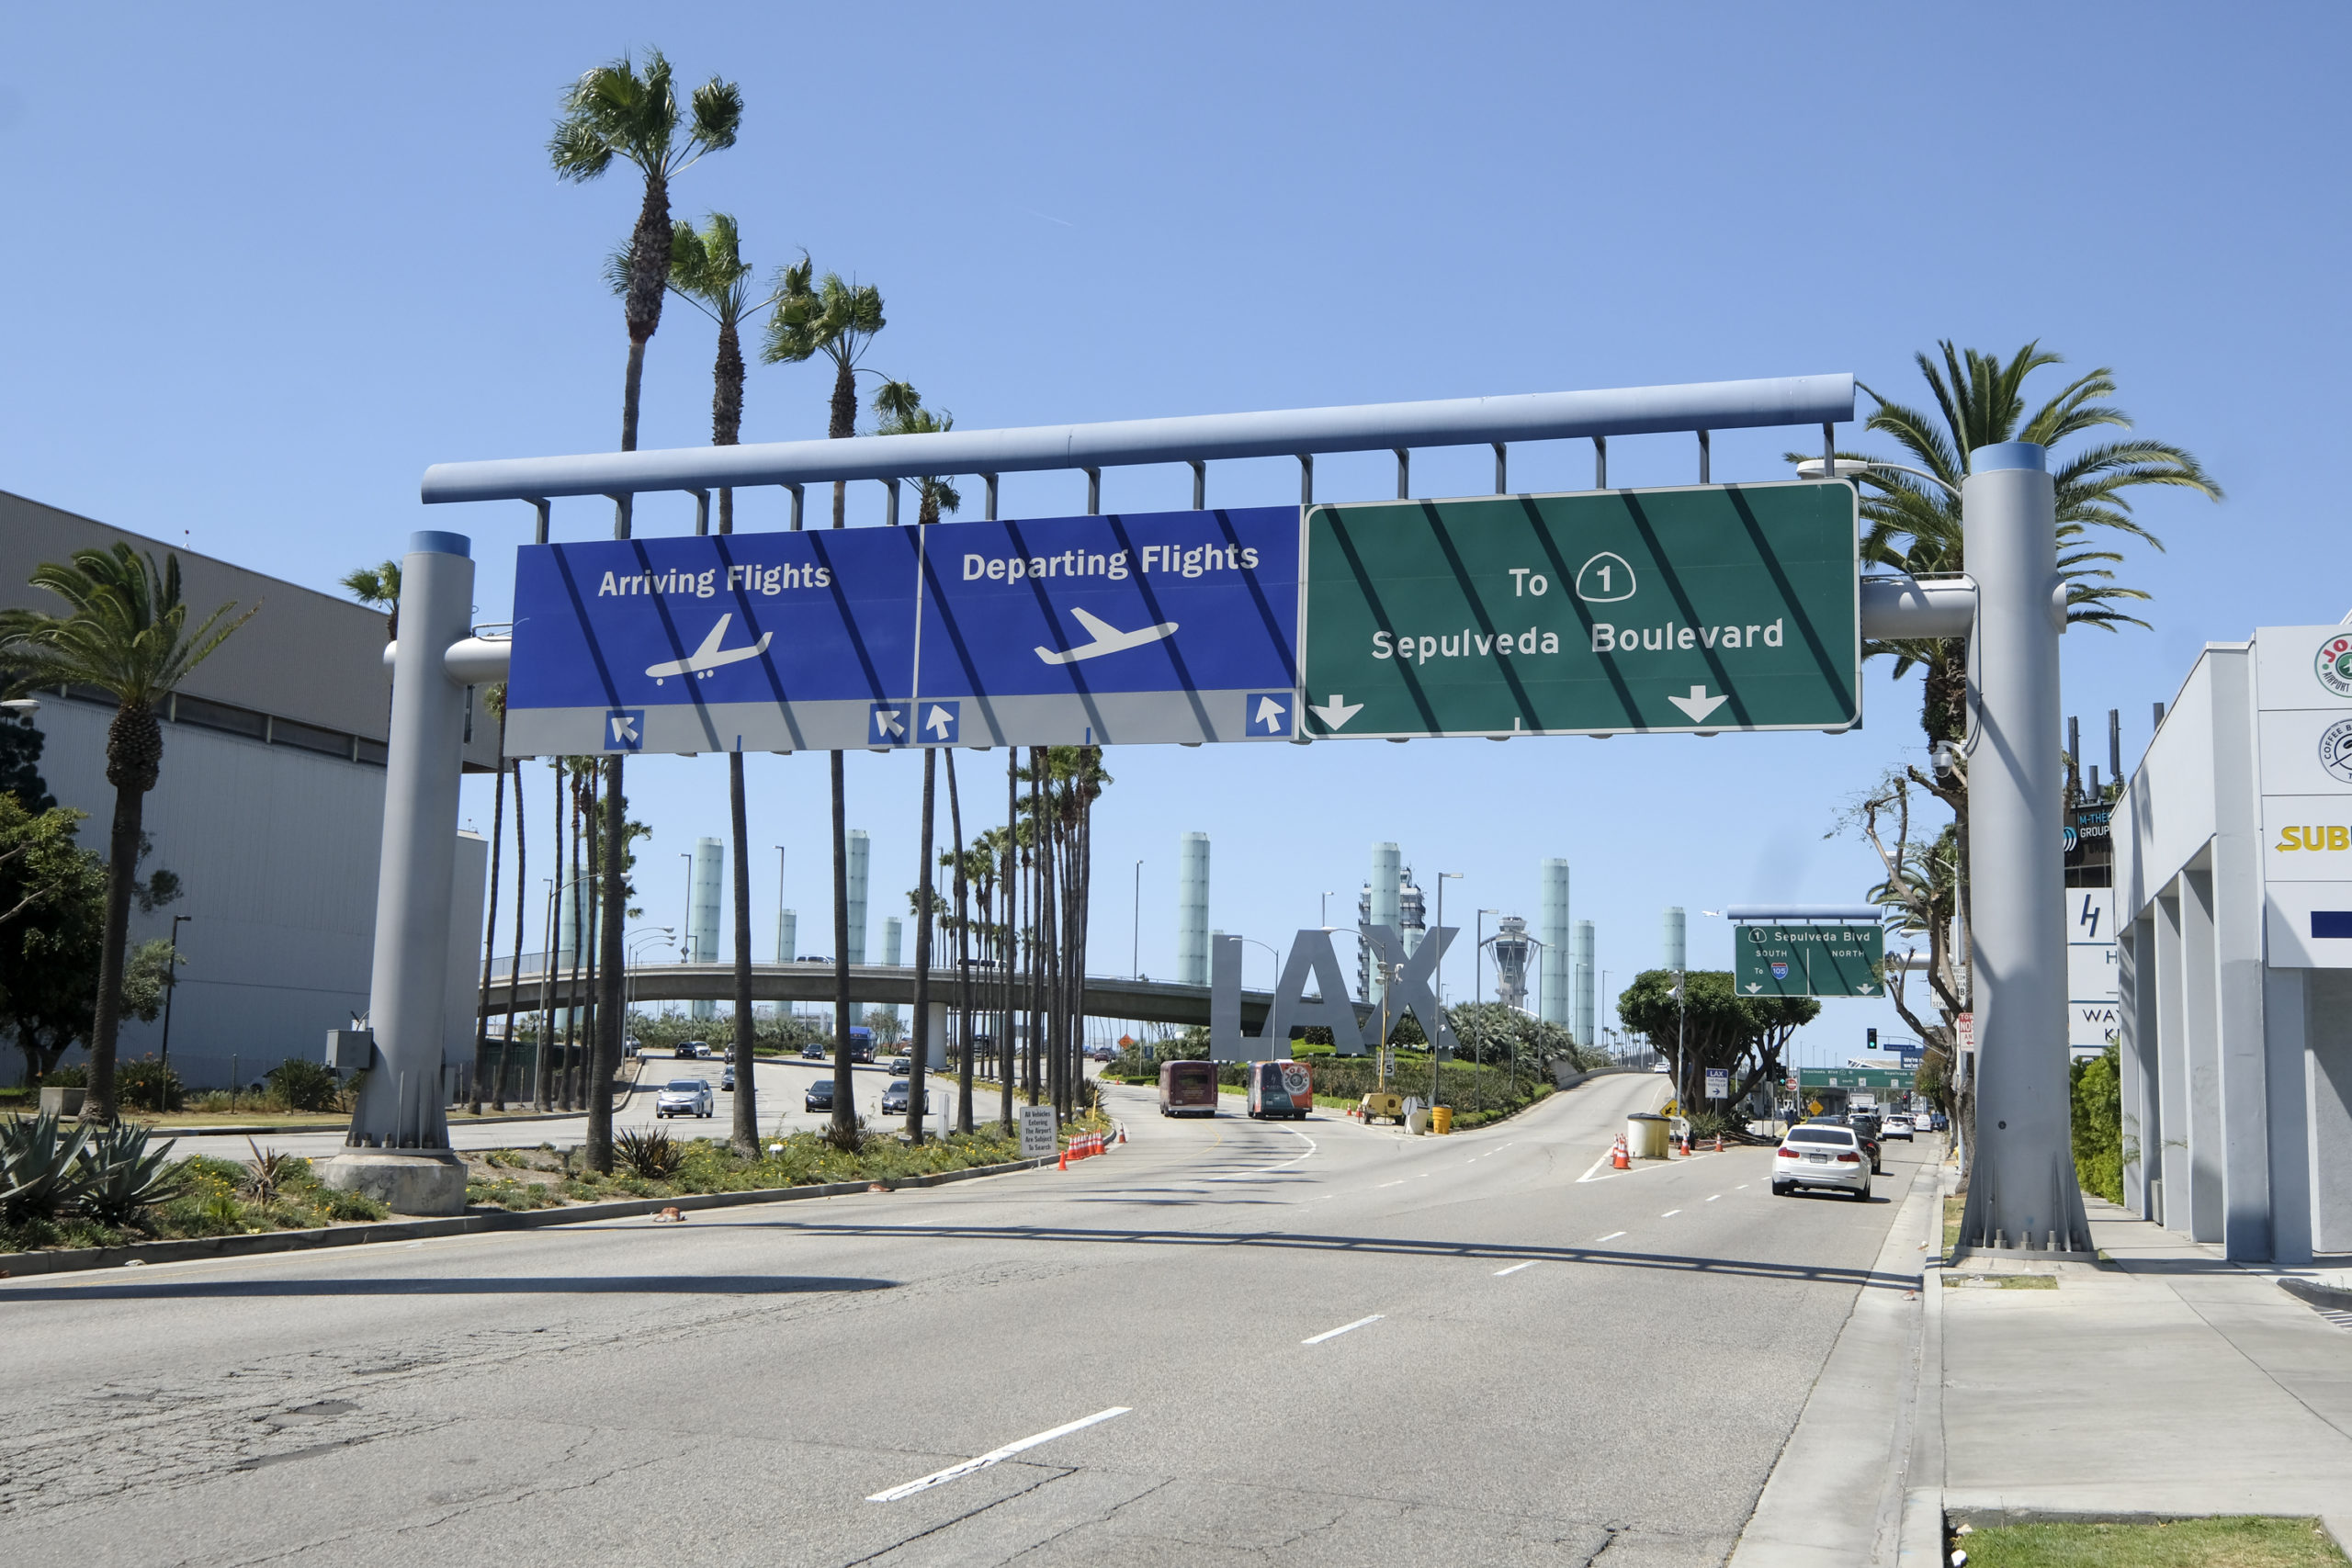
[0,543,261,1123]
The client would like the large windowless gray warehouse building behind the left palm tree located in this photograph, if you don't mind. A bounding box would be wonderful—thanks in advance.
[0,491,499,1086]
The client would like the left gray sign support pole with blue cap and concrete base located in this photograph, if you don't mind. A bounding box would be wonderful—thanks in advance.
[324,531,473,1213]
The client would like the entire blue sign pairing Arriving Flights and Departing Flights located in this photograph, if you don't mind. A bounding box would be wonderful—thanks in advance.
[505,505,1298,757]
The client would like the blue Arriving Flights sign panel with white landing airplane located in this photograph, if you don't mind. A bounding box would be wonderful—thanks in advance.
[505,529,922,757]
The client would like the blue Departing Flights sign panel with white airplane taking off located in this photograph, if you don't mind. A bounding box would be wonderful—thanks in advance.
[915,505,1298,745]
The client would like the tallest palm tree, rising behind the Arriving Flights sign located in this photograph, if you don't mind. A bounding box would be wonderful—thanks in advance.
[548,50,743,1170]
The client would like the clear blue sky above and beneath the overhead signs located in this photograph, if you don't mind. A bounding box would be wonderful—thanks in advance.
[0,5,2352,1060]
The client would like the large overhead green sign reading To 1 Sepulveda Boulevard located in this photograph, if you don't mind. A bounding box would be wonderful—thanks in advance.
[1298,479,1863,739]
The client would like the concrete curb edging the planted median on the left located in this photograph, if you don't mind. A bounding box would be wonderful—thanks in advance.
[0,1156,1056,1277]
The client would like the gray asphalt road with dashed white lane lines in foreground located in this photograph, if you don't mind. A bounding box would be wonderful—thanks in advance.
[0,1077,1933,1568]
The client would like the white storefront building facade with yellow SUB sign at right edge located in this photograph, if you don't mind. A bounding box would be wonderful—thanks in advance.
[2114,626,2352,1262]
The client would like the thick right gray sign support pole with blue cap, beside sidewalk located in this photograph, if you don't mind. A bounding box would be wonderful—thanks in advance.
[1959,442,2091,1251]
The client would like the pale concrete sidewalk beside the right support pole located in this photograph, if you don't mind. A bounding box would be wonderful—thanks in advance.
[1903,1199,2352,1563]
